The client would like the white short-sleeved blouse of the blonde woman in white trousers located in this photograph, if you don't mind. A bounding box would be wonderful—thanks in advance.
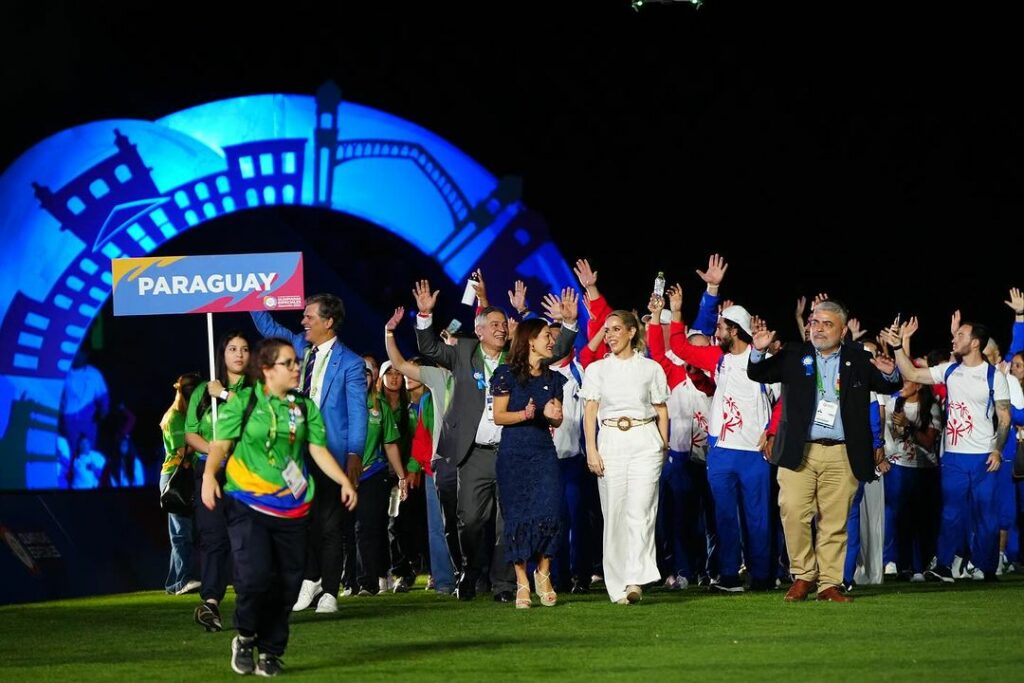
[580,353,669,420]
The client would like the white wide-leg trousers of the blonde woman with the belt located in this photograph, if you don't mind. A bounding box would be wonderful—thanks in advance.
[597,422,664,602]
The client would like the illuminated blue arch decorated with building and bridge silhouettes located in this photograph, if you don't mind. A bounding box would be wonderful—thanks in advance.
[0,83,572,488]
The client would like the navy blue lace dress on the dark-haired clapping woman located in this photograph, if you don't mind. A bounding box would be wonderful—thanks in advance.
[490,366,565,562]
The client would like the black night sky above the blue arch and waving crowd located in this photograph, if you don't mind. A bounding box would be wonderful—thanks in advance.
[0,0,1024,458]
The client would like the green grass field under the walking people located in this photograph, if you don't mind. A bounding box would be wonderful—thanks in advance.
[0,574,1024,683]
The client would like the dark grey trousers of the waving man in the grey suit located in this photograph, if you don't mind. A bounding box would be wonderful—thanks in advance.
[459,446,515,593]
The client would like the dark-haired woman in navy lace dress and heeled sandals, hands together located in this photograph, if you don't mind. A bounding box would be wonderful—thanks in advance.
[490,318,565,609]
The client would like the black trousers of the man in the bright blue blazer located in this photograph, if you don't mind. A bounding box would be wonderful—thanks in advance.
[304,458,347,597]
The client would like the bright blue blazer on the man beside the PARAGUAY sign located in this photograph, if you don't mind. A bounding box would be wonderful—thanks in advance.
[252,311,368,468]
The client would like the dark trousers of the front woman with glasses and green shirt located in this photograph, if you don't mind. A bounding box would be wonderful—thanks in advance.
[223,496,308,656]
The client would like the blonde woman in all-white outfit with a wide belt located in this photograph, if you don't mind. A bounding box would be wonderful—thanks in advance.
[580,310,669,604]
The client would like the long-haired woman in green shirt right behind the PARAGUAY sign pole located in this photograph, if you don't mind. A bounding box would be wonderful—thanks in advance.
[185,330,251,631]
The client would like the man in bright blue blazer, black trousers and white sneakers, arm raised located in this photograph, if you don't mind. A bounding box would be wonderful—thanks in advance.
[252,294,367,612]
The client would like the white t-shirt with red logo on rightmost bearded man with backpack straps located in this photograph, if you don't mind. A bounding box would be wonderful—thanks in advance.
[929,362,1010,455]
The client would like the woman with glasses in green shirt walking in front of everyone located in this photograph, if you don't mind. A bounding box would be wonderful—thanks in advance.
[203,338,356,676]
